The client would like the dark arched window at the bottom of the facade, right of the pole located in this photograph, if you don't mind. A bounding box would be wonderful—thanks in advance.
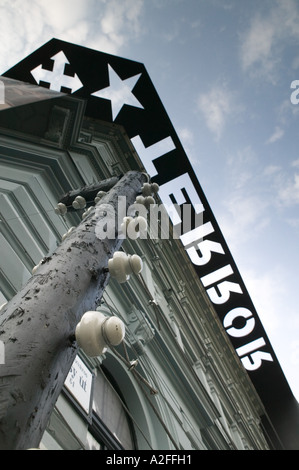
[41,359,136,450]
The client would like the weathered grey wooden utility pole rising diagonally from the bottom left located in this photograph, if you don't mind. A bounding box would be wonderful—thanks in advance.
[0,171,147,450]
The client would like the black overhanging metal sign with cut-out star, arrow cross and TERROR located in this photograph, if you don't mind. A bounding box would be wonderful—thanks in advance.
[3,39,299,448]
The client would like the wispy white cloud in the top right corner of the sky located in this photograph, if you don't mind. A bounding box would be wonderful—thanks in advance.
[240,0,299,83]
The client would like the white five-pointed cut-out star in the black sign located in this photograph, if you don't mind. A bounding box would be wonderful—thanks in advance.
[92,64,143,121]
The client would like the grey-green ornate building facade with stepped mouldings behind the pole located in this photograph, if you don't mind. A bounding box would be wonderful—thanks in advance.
[0,91,273,450]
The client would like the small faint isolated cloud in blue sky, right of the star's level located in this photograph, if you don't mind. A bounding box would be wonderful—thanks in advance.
[197,87,236,140]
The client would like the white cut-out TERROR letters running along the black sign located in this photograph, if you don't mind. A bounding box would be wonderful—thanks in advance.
[134,138,273,371]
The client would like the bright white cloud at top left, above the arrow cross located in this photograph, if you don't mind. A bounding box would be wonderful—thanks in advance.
[0,0,144,73]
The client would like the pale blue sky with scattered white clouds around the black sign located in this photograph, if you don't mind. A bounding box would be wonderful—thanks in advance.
[0,0,299,400]
